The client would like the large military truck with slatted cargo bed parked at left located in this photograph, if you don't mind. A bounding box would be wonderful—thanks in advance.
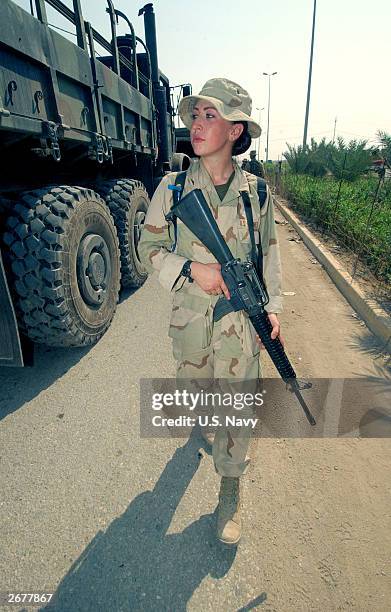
[0,0,191,365]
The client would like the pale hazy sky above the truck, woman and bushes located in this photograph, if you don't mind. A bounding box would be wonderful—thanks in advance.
[13,0,391,159]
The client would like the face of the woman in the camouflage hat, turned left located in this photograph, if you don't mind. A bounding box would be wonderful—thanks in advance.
[190,100,243,157]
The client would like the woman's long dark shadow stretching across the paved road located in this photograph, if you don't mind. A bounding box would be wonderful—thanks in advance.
[41,431,236,612]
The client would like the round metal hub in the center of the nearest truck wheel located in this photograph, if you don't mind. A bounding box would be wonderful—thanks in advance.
[77,234,111,306]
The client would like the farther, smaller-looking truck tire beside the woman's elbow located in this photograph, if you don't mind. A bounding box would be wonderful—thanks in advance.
[95,179,150,288]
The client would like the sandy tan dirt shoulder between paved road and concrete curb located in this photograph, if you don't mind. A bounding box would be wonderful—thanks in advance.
[242,207,391,612]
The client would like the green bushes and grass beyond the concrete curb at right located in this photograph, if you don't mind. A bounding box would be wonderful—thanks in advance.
[279,131,391,284]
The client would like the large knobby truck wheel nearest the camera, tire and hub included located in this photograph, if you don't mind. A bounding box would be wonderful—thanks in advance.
[3,186,120,346]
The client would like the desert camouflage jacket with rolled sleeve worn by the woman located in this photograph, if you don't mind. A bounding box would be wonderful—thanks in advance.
[138,160,282,355]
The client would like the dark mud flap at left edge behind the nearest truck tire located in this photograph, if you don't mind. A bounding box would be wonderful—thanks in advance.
[0,251,24,366]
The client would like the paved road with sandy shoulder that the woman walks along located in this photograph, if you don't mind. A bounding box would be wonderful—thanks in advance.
[0,208,391,612]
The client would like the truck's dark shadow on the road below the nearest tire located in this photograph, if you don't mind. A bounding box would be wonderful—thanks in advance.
[0,344,93,421]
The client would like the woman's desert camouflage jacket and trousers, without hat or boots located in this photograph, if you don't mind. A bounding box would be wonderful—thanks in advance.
[138,160,282,476]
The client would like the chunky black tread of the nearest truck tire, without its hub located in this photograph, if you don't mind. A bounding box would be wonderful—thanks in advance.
[3,185,119,346]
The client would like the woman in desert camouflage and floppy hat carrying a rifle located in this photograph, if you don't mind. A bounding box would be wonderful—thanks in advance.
[138,78,282,544]
